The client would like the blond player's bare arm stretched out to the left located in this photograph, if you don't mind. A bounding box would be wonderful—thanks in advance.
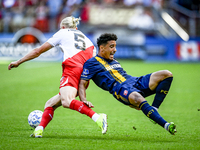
[8,42,52,70]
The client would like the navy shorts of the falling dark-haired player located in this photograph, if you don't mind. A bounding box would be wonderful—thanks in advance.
[112,74,155,105]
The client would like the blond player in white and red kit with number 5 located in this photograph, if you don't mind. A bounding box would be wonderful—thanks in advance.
[8,16,107,138]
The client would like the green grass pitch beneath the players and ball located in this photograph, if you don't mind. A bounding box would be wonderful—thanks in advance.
[0,60,200,150]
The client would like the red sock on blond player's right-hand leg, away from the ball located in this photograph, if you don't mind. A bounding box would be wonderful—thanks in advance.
[69,99,95,118]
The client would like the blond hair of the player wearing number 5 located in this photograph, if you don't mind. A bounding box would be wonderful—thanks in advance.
[60,16,81,28]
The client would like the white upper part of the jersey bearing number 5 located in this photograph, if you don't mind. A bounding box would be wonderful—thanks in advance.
[47,29,96,62]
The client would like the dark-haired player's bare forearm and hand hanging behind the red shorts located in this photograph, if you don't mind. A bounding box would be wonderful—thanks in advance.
[78,80,94,108]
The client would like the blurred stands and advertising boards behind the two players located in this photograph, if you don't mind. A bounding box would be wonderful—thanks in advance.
[0,0,200,61]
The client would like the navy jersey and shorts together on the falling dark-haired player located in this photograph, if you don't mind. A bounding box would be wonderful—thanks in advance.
[81,55,150,105]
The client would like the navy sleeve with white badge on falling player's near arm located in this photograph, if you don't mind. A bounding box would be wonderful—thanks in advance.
[81,60,96,81]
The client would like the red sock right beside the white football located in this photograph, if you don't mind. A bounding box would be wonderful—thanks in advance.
[39,107,54,128]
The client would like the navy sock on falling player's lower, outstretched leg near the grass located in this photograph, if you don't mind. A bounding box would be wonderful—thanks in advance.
[139,101,167,128]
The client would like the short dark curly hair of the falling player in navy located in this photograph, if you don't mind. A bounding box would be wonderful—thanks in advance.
[97,33,118,47]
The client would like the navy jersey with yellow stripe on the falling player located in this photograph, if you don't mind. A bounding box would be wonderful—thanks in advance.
[81,55,131,93]
